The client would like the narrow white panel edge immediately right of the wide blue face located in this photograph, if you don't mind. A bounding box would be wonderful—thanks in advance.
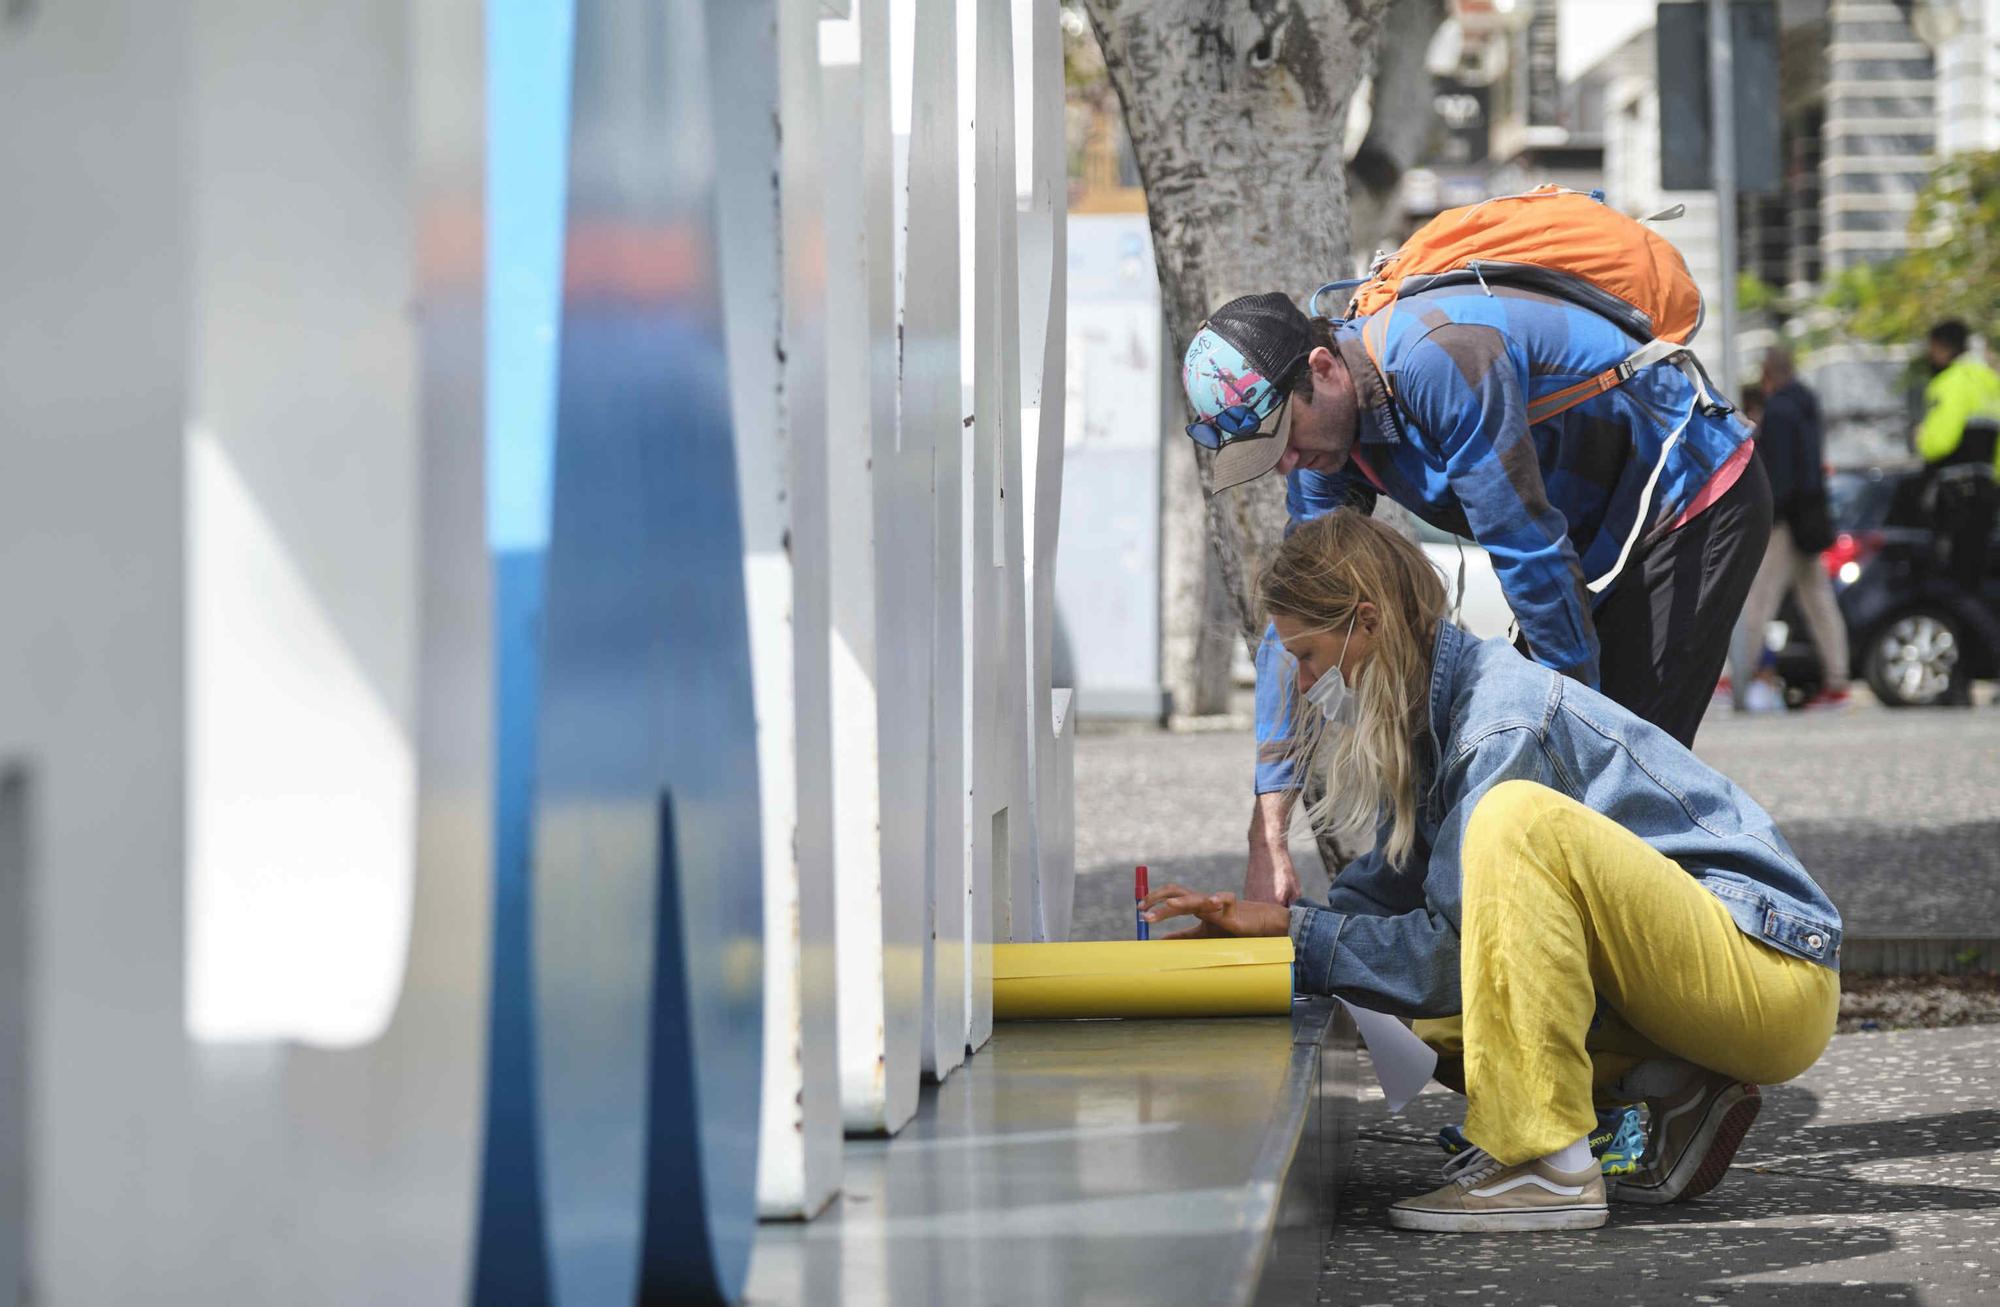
[708,0,840,1217]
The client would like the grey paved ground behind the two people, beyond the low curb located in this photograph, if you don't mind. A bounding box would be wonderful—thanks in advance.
[1072,707,2000,939]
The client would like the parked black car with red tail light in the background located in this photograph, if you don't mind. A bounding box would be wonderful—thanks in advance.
[1778,464,2000,707]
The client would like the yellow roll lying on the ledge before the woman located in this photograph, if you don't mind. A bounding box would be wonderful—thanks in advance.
[994,935,1292,1021]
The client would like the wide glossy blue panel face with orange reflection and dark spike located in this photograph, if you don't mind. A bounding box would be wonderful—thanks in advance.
[532,0,762,1303]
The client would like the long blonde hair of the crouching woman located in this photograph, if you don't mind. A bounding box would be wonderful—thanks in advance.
[1258,508,1446,865]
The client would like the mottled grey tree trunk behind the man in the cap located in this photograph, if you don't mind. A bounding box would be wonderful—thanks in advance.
[1084,0,1390,695]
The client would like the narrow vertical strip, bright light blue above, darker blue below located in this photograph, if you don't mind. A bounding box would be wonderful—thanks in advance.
[472,0,574,1307]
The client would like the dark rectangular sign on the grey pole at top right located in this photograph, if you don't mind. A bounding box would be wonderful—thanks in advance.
[1654,0,1784,194]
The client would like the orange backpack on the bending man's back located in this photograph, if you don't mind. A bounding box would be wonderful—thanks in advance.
[1310,186,1730,424]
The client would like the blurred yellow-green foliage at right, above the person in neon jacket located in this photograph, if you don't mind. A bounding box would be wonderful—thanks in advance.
[1822,150,2000,344]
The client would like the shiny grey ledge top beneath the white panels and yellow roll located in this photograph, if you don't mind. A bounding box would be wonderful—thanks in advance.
[748,999,1356,1307]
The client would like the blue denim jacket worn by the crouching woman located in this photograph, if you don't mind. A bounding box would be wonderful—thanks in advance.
[1292,622,1840,1017]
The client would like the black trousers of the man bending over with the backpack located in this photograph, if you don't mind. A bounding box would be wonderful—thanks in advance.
[1596,458,1770,745]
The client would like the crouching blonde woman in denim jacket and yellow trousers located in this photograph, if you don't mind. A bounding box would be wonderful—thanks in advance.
[1146,510,1840,1231]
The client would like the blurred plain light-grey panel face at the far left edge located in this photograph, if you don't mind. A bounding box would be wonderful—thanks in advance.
[0,4,194,1303]
